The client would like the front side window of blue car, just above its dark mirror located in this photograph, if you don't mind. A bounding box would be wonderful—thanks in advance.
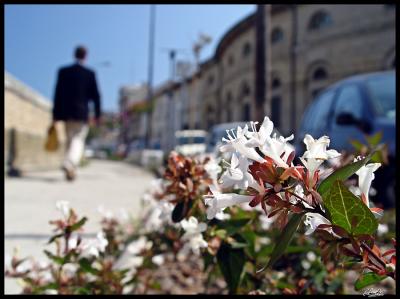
[335,84,363,119]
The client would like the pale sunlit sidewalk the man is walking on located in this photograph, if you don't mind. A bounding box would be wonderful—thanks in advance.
[4,160,153,294]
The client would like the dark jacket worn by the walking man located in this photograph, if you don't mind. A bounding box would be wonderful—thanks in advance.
[53,63,101,121]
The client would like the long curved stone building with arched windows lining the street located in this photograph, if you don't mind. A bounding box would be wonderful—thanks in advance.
[145,4,396,154]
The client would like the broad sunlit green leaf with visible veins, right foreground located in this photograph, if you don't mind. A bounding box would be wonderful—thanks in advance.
[323,180,378,235]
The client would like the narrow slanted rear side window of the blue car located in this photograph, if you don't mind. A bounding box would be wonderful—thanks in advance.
[310,90,335,137]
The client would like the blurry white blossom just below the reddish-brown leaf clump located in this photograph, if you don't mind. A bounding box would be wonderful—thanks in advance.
[180,216,208,254]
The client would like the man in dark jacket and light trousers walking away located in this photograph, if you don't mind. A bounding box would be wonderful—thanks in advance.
[53,46,101,181]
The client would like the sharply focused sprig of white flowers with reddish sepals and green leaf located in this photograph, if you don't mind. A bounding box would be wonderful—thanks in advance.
[204,117,395,282]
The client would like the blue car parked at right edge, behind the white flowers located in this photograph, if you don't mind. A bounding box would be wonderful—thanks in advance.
[295,71,396,207]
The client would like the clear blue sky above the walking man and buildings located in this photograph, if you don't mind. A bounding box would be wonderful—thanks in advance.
[4,4,256,112]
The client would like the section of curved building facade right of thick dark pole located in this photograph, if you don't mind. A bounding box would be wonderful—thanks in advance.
[265,4,396,133]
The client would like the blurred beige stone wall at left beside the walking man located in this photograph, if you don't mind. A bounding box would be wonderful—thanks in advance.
[4,72,65,173]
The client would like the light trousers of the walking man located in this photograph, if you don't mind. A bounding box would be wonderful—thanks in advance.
[63,121,89,170]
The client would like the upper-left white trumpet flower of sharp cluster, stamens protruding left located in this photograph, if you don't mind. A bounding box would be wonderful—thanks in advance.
[220,125,265,163]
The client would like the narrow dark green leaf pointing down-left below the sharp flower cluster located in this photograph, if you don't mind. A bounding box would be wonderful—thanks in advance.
[258,213,304,272]
